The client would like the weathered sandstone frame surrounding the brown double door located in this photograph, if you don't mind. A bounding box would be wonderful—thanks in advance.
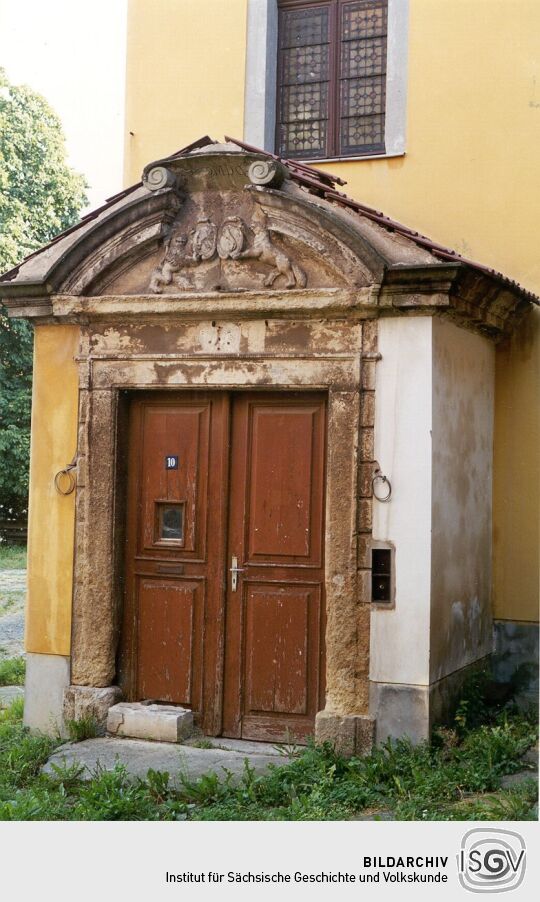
[71,349,369,736]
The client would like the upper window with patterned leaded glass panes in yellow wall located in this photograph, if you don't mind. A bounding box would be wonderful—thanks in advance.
[277,0,388,159]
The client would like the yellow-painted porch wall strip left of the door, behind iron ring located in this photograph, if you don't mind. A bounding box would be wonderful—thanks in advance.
[25,326,79,655]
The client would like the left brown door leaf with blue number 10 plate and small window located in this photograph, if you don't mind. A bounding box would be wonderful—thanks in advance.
[121,392,229,734]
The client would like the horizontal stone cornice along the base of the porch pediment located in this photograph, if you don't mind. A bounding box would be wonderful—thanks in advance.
[2,274,529,340]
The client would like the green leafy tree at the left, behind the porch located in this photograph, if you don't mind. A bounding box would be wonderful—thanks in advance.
[0,68,86,518]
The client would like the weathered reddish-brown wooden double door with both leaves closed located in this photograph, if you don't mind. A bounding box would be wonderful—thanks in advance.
[121,391,326,740]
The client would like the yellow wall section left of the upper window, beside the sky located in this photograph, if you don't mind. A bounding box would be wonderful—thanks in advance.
[125,0,247,184]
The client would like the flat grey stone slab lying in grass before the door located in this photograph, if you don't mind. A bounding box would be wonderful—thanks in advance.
[42,737,290,784]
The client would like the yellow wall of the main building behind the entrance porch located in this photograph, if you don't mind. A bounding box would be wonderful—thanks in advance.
[121,0,540,620]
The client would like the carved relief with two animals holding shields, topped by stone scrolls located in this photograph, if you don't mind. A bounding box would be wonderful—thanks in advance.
[92,145,380,295]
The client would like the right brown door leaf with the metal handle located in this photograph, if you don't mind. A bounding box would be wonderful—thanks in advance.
[223,393,326,740]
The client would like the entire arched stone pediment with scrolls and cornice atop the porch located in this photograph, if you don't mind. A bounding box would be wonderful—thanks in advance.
[0,138,535,338]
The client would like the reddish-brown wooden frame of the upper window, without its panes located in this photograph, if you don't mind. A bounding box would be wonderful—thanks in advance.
[273,0,392,162]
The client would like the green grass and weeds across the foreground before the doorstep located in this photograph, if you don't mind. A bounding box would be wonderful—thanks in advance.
[0,702,537,821]
